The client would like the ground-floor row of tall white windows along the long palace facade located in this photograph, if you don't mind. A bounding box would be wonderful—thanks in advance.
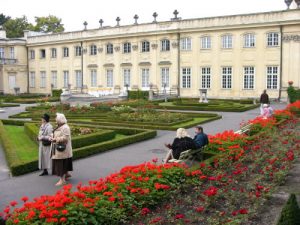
[29,66,279,90]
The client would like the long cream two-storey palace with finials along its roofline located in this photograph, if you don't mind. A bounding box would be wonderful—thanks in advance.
[0,4,300,99]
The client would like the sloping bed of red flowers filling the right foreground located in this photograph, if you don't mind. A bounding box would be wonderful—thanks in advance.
[3,101,300,225]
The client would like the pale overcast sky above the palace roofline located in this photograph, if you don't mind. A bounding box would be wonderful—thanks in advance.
[0,0,294,31]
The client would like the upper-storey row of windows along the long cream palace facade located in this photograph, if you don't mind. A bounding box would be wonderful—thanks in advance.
[28,32,279,59]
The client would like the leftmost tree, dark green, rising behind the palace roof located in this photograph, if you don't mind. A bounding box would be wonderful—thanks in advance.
[3,16,34,38]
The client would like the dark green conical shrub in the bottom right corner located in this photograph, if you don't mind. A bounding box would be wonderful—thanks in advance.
[277,194,300,225]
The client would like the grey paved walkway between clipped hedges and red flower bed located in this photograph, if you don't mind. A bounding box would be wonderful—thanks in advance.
[0,103,286,211]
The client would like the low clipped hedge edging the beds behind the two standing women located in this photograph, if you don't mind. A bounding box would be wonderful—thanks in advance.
[0,120,156,176]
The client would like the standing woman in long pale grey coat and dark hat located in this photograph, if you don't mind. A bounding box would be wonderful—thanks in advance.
[38,113,53,176]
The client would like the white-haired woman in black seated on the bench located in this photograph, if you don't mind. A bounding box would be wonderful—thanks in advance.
[164,128,195,163]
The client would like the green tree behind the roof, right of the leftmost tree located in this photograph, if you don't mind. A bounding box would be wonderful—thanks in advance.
[34,15,65,33]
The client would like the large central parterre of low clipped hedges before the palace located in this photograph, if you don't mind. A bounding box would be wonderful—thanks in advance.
[10,102,221,130]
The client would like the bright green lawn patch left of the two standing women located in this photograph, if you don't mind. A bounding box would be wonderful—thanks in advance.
[4,125,38,161]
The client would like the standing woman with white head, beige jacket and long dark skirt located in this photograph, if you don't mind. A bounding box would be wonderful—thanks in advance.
[51,113,73,186]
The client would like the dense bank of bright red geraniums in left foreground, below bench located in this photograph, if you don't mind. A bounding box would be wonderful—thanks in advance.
[4,163,186,224]
